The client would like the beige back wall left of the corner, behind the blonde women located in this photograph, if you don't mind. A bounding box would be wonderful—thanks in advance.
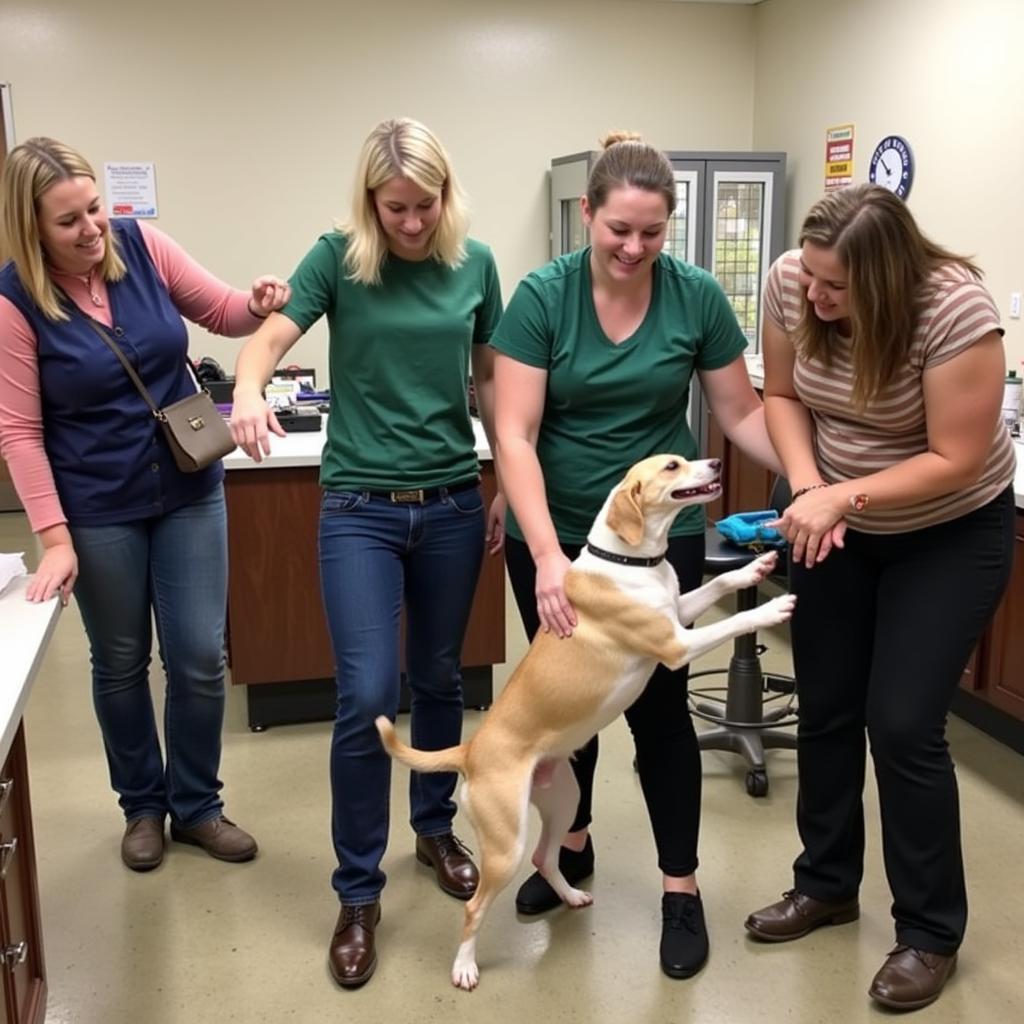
[0,0,755,382]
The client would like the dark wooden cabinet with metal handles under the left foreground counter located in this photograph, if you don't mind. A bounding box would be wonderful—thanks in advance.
[0,725,46,1024]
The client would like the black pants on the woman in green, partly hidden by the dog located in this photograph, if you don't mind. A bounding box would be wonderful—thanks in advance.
[505,535,703,878]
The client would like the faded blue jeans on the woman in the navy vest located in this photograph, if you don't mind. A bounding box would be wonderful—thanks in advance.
[71,484,227,828]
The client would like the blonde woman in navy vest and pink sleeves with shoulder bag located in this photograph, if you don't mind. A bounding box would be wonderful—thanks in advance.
[0,137,288,871]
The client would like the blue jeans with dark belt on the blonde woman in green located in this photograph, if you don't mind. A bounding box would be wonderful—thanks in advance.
[319,488,484,904]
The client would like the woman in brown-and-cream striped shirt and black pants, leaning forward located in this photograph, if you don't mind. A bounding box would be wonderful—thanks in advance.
[746,185,1015,1010]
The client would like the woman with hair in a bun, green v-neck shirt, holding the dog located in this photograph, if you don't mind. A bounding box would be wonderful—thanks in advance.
[490,133,778,978]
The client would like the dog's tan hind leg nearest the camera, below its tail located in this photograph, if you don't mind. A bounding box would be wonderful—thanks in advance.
[452,772,530,992]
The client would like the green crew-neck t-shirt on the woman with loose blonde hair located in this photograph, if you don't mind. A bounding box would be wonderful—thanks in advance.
[282,231,502,490]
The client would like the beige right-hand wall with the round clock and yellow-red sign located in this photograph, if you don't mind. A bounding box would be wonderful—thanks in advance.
[754,0,1024,367]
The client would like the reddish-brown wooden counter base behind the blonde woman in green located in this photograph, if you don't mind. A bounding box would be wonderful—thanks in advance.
[224,462,505,724]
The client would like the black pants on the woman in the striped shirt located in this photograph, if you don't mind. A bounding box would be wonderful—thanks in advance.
[790,488,1014,955]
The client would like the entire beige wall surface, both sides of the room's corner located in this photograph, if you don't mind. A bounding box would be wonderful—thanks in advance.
[6,0,1024,371]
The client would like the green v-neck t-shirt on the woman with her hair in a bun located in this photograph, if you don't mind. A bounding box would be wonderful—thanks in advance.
[490,247,746,544]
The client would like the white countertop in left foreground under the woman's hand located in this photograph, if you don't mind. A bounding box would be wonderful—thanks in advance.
[0,577,60,763]
